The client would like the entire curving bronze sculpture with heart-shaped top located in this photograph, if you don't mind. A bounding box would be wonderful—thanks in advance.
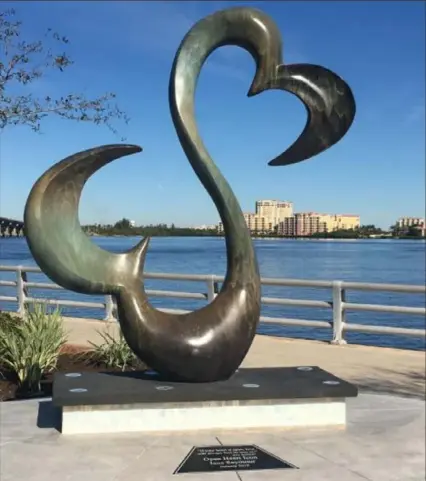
[24,7,355,382]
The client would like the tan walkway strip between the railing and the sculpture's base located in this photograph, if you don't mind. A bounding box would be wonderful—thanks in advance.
[66,318,426,399]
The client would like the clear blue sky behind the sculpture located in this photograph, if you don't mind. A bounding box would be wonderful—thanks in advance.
[0,1,425,227]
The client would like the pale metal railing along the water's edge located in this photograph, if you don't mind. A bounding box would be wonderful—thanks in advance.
[0,266,426,344]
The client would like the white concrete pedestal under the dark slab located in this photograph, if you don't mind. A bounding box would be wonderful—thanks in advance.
[62,399,346,434]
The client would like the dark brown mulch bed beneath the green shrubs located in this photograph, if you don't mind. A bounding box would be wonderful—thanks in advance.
[0,345,146,402]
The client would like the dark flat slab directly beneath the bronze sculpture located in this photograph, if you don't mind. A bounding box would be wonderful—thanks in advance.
[53,366,358,407]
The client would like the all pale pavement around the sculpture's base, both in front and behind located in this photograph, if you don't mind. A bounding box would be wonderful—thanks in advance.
[0,318,425,481]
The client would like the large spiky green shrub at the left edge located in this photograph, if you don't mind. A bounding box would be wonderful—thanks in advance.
[0,304,67,392]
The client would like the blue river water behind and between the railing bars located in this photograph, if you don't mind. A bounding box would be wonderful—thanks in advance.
[0,237,425,348]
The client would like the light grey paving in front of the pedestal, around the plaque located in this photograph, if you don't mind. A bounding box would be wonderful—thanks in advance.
[0,394,425,481]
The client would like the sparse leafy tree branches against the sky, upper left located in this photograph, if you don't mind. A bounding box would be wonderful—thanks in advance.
[0,9,129,134]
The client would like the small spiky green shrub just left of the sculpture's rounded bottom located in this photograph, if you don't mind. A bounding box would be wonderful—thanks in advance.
[90,328,142,371]
